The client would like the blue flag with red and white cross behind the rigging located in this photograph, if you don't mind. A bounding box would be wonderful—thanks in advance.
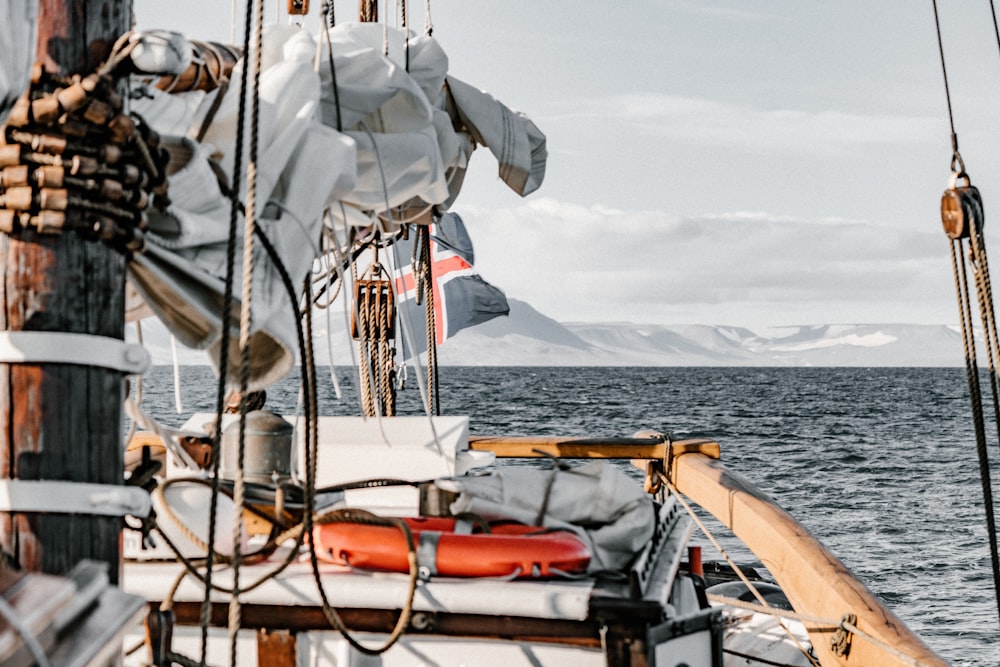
[394,213,510,359]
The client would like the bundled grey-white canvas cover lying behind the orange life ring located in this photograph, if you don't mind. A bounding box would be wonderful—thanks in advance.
[436,461,655,572]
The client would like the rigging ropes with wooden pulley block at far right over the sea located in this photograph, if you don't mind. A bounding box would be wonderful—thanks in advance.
[932,0,1000,632]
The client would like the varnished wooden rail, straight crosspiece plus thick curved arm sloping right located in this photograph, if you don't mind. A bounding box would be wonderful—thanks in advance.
[469,436,948,667]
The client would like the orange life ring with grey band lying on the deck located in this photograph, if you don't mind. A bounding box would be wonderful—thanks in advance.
[313,517,590,578]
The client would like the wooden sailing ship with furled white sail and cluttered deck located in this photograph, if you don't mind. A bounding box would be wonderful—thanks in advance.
[0,0,988,667]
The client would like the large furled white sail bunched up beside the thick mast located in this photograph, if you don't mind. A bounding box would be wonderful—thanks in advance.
[129,24,546,388]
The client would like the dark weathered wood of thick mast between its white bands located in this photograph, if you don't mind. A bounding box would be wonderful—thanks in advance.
[0,0,132,583]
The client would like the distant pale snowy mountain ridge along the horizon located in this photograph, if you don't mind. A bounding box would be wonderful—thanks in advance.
[133,299,964,367]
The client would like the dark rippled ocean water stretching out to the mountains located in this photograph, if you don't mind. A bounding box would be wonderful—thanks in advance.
[135,367,1000,667]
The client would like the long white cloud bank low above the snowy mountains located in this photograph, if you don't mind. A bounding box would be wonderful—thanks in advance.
[457,198,957,326]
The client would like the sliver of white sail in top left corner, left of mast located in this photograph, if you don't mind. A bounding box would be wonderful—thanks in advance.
[0,0,38,123]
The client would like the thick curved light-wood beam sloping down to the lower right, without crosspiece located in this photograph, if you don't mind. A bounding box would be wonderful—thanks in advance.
[669,453,947,667]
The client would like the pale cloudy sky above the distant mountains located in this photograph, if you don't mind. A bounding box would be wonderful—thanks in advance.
[127,0,1000,330]
